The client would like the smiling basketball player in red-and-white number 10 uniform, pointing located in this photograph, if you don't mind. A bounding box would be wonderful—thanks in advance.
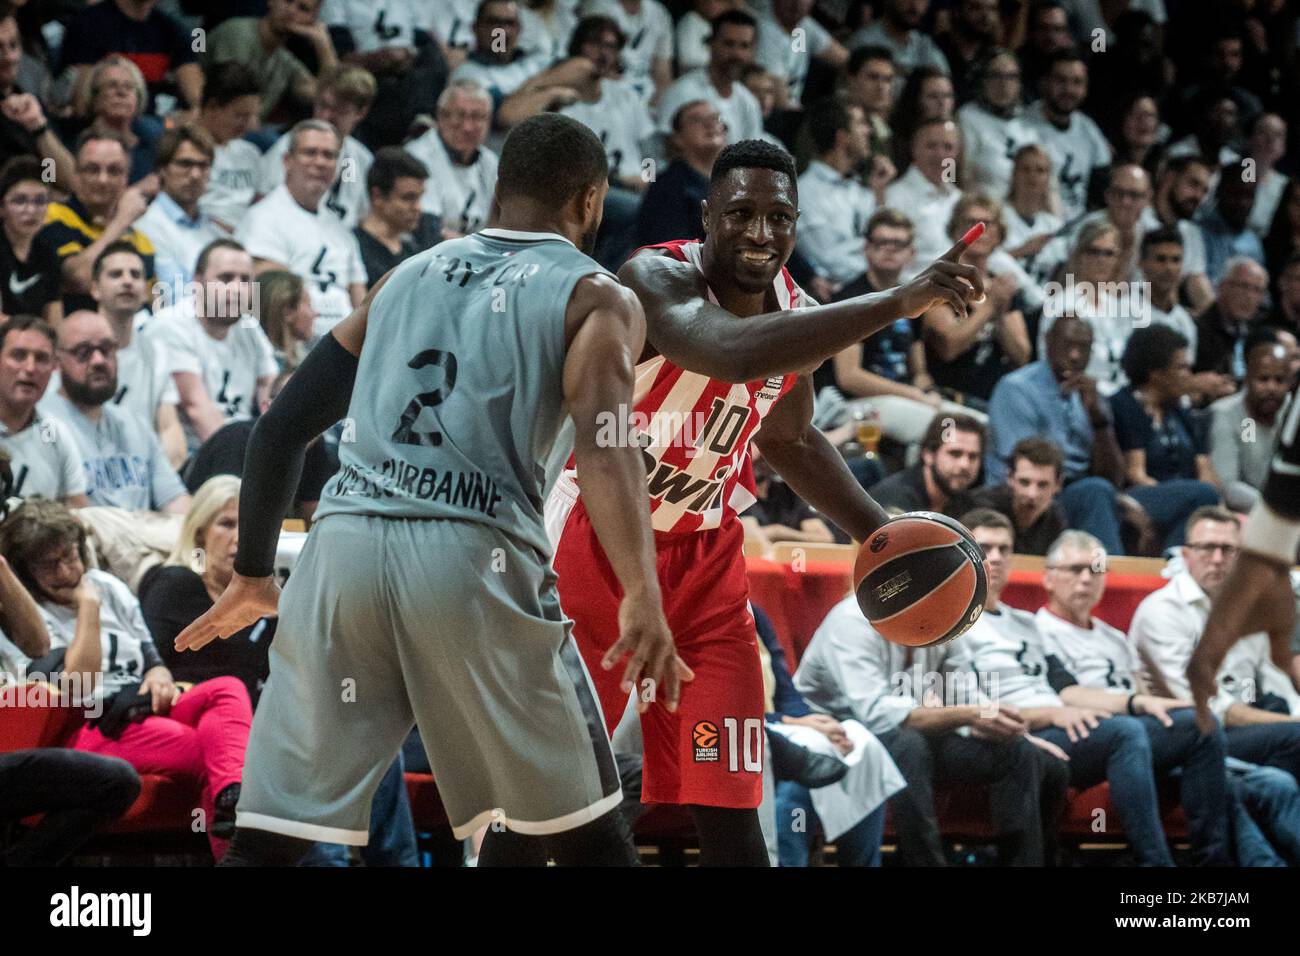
[484,140,983,866]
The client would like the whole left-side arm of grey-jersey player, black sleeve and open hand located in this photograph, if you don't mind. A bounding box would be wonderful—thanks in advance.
[176,273,391,650]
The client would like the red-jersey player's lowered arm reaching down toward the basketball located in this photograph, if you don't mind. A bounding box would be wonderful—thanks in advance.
[754,376,889,541]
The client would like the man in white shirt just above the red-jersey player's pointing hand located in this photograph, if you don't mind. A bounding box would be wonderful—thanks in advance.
[884,120,962,281]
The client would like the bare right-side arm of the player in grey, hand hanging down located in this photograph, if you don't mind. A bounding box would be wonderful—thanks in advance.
[564,274,693,710]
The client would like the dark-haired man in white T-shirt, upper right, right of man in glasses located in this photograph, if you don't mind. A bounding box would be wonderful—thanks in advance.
[1024,51,1110,222]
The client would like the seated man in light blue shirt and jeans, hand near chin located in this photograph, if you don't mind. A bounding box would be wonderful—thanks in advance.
[984,315,1123,554]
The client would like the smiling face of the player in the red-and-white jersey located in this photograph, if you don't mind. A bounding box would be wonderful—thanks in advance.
[703,168,798,294]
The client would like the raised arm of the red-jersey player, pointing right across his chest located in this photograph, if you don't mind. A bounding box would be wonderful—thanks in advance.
[619,234,984,382]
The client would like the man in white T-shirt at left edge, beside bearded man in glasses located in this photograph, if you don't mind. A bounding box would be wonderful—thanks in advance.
[0,316,88,507]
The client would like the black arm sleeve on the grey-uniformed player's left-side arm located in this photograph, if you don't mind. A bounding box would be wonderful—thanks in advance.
[235,334,359,578]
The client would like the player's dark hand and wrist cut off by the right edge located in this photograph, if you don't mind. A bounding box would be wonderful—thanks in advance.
[1187,551,1296,734]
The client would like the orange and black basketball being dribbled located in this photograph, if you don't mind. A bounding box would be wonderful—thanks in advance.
[853,511,988,648]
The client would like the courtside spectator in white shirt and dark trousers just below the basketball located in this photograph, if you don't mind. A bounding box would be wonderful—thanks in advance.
[794,582,1069,866]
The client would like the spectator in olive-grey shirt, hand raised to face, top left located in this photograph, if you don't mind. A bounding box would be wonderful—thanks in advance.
[205,0,338,122]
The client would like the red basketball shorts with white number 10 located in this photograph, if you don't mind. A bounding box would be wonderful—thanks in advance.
[555,499,764,808]
